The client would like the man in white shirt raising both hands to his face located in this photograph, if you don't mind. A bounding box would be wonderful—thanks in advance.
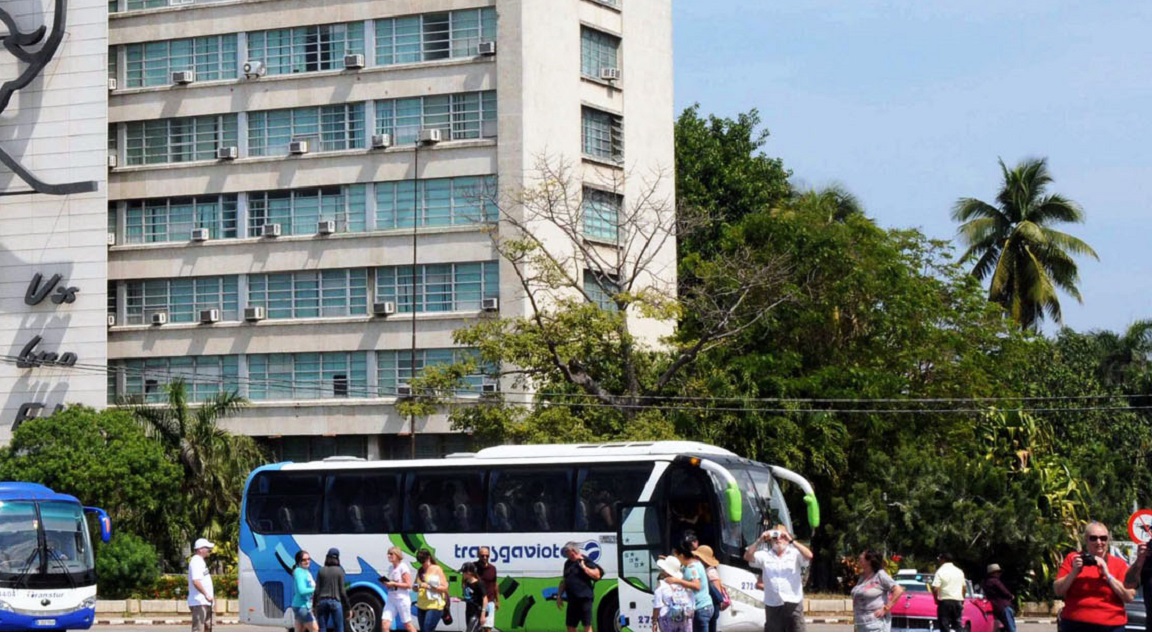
[744,525,812,632]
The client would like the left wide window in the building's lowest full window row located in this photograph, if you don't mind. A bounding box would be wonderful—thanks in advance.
[115,356,240,404]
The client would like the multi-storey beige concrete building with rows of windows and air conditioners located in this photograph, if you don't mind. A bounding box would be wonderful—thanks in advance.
[4,0,675,459]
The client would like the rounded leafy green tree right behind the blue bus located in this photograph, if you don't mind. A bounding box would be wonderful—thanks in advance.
[0,405,188,568]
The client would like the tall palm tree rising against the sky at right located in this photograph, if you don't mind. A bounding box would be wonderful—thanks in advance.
[952,158,1099,329]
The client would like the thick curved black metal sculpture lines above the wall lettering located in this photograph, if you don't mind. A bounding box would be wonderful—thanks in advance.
[0,0,97,196]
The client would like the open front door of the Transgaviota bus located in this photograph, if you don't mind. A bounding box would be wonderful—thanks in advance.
[617,502,670,631]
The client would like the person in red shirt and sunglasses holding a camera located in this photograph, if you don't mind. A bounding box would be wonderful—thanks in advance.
[1053,523,1136,631]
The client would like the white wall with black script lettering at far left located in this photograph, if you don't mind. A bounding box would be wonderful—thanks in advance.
[0,0,107,443]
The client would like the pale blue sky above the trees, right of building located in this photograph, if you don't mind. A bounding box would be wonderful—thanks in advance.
[673,0,1152,334]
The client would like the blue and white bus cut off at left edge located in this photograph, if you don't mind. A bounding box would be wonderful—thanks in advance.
[0,482,112,631]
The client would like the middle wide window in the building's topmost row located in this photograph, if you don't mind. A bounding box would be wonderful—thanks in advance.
[248,22,364,76]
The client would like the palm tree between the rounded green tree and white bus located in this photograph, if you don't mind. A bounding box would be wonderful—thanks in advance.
[118,379,264,545]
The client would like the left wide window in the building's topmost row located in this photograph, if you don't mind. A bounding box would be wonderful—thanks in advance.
[124,33,236,87]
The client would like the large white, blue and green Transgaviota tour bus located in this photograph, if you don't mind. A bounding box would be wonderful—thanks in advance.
[240,442,819,631]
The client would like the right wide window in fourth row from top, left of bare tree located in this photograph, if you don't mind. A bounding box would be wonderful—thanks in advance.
[376,260,500,313]
